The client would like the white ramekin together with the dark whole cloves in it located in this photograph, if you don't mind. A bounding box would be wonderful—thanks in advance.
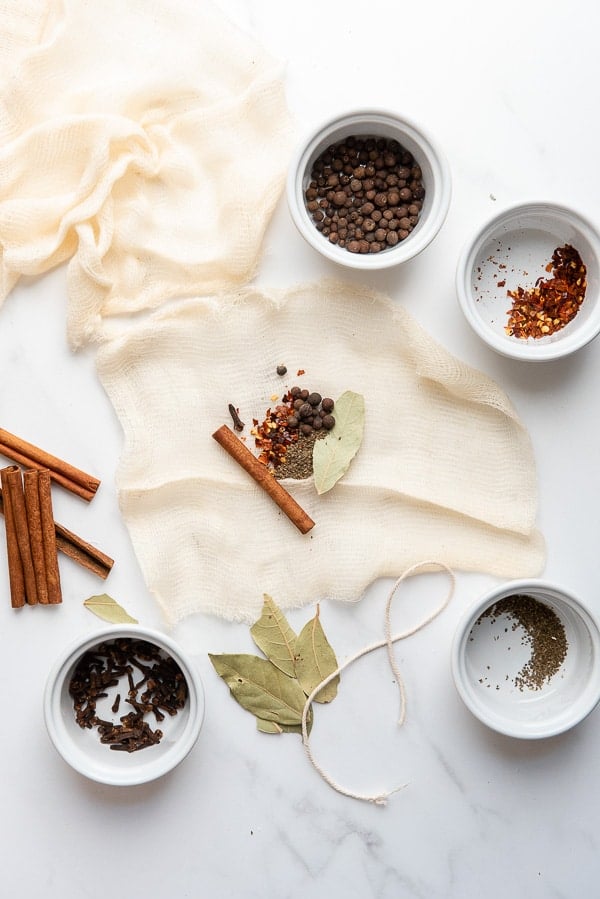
[44,624,204,786]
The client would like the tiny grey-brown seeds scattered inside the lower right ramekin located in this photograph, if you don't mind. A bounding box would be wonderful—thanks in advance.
[475,594,568,690]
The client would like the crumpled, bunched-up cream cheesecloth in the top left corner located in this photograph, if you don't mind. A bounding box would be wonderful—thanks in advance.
[0,0,293,347]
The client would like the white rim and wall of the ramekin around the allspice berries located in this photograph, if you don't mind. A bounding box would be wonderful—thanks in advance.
[286,107,452,270]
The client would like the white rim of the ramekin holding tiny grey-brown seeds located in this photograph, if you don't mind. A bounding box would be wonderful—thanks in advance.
[451,578,600,740]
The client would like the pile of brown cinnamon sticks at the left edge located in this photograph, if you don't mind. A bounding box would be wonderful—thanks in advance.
[0,428,113,609]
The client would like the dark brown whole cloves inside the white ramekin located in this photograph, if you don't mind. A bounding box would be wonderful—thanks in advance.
[69,637,187,752]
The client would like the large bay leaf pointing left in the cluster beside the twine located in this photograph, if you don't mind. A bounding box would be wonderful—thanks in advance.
[208,653,306,724]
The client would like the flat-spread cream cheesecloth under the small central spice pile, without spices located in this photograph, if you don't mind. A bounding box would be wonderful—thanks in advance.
[97,282,545,622]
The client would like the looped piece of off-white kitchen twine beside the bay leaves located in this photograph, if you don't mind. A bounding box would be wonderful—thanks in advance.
[302,560,456,805]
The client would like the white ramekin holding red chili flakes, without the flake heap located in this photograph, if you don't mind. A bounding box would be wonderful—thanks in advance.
[456,202,600,362]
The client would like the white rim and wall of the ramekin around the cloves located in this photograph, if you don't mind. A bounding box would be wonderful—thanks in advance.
[43,624,205,786]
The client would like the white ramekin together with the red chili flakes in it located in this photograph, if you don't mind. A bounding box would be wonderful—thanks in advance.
[456,202,600,362]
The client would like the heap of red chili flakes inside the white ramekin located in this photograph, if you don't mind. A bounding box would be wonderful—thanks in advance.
[505,244,587,338]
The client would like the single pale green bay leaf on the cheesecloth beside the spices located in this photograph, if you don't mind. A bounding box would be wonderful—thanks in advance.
[313,390,365,494]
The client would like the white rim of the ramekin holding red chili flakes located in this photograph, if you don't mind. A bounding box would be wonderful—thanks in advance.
[455,199,600,362]
